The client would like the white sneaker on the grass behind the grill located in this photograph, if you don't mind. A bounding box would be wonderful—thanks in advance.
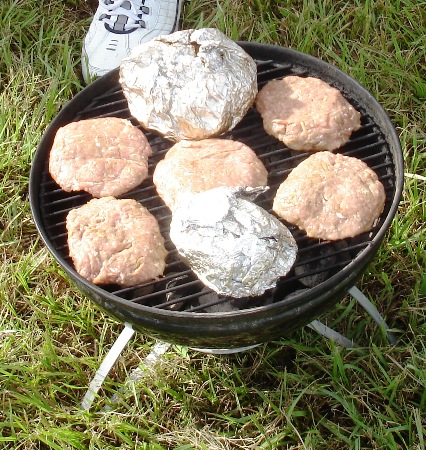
[82,0,182,83]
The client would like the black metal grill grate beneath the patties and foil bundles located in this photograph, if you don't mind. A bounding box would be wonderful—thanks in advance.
[35,56,395,313]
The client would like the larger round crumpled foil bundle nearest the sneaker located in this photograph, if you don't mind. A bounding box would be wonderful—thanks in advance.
[120,28,257,141]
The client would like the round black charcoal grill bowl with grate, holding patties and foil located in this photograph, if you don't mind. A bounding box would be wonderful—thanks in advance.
[30,42,403,349]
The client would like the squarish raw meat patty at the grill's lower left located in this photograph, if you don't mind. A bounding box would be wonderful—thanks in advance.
[66,197,167,286]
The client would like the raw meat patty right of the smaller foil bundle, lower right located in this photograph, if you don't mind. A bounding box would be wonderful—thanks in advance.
[272,152,385,240]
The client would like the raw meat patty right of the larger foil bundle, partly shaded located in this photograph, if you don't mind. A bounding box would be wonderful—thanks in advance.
[256,76,361,151]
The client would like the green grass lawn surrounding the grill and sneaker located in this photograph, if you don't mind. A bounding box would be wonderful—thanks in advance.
[0,0,426,450]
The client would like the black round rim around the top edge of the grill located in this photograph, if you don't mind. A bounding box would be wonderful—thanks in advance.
[29,41,404,342]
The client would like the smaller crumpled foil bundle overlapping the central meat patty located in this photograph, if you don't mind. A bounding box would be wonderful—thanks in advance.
[170,187,297,297]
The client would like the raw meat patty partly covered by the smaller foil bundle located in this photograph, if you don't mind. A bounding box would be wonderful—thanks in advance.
[153,139,268,208]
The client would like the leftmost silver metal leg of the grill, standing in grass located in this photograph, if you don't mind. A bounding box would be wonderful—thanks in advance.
[81,323,135,410]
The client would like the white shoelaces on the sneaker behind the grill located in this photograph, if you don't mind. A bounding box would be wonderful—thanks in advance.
[99,0,150,31]
